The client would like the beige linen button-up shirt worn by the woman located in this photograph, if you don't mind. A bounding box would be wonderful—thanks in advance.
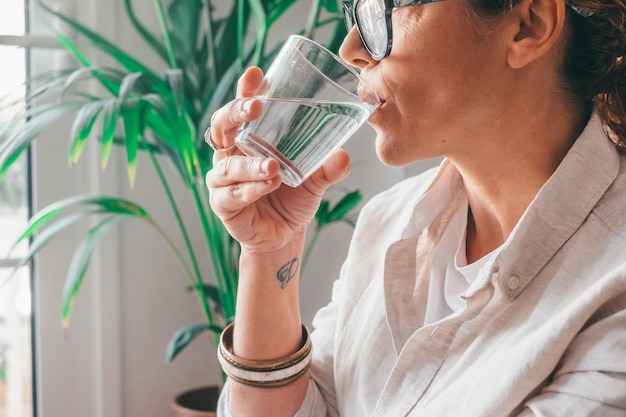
[220,115,626,417]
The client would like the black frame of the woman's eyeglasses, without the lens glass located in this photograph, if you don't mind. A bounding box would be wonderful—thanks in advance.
[342,0,593,61]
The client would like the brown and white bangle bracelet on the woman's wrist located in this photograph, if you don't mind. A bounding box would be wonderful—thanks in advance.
[217,323,312,388]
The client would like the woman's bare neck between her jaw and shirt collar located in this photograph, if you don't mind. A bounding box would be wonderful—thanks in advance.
[448,102,586,262]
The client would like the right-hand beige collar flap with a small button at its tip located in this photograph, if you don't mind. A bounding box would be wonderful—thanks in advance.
[493,112,620,299]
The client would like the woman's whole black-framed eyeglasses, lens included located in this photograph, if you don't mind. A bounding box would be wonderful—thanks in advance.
[343,0,593,61]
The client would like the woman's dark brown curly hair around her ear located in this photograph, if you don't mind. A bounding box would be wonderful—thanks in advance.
[466,0,626,153]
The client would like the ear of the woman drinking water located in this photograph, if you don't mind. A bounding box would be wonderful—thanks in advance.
[507,0,565,69]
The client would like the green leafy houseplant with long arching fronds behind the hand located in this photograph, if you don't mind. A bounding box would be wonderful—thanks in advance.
[0,0,361,368]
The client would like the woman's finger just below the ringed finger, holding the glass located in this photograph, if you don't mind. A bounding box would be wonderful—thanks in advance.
[206,155,280,188]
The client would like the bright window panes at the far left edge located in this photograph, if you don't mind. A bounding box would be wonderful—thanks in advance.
[0,0,33,417]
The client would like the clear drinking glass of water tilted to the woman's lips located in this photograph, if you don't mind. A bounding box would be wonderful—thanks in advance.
[235,35,379,187]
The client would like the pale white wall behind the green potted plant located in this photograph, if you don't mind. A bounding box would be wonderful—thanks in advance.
[29,0,434,417]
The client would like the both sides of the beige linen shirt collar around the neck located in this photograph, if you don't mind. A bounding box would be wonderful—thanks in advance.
[394,112,620,299]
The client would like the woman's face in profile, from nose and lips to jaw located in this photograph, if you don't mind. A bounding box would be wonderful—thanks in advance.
[340,0,507,166]
